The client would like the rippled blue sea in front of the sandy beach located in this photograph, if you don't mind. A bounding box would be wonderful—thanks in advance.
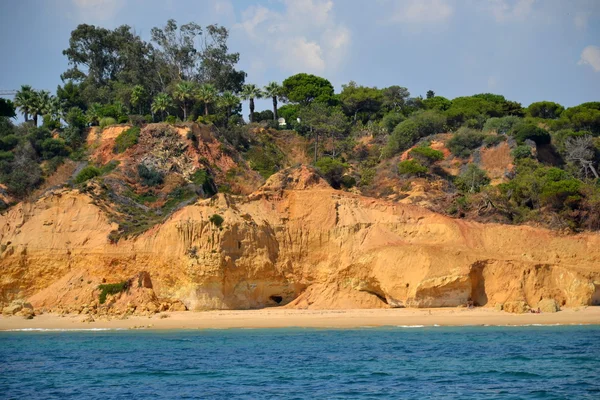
[0,325,600,400]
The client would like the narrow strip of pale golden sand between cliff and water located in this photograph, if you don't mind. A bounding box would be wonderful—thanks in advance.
[0,307,600,331]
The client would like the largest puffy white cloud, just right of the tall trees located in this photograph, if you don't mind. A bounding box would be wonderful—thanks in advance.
[234,0,351,73]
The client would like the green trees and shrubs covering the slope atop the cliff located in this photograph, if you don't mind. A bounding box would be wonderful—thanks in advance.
[0,20,600,241]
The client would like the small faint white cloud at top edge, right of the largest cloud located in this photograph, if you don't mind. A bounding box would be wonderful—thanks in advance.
[390,0,454,24]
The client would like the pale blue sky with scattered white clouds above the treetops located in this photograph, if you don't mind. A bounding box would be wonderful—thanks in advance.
[0,0,600,115]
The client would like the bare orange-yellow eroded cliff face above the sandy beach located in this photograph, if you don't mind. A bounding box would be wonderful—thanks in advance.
[0,167,600,310]
